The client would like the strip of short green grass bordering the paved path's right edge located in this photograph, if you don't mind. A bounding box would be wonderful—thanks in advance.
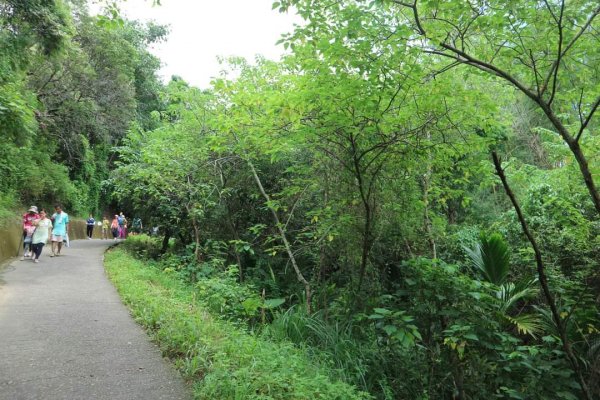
[105,248,370,400]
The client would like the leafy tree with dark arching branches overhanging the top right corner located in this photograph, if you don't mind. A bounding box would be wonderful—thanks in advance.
[380,0,600,214]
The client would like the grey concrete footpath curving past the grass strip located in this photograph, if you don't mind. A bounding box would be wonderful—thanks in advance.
[0,239,192,400]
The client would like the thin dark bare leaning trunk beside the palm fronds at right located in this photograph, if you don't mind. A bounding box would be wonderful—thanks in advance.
[492,151,592,400]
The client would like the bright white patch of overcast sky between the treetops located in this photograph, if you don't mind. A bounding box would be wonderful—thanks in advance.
[111,0,300,88]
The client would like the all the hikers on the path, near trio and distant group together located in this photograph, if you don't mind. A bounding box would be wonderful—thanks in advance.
[21,204,143,263]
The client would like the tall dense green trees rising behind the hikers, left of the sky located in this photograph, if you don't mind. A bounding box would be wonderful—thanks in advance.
[0,0,165,215]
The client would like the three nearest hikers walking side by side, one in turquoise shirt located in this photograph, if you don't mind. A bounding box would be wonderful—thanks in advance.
[21,204,69,263]
